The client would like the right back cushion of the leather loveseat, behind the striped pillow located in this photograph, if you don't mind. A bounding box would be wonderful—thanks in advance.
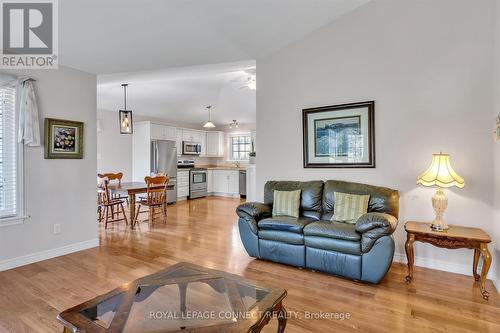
[322,180,399,220]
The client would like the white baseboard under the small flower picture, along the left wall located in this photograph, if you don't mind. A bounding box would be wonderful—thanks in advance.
[0,238,99,272]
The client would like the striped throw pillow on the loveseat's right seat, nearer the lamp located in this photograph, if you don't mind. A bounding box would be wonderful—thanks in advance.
[331,192,370,223]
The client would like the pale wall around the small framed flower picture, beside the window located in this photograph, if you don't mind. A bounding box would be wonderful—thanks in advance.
[0,67,99,270]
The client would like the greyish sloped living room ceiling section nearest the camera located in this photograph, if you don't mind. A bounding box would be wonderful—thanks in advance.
[59,0,369,74]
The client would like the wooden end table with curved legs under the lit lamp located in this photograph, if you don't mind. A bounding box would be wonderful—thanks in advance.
[405,222,491,300]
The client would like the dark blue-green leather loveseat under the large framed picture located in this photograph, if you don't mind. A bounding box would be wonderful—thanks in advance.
[236,180,399,283]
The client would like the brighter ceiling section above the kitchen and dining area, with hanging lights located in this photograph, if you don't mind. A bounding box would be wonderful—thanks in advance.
[97,61,256,126]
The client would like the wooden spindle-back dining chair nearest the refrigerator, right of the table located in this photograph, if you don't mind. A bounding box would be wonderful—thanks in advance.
[132,176,169,225]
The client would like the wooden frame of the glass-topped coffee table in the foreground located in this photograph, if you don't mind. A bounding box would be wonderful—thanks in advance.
[57,263,287,333]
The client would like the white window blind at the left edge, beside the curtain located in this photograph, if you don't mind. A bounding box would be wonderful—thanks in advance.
[0,86,19,219]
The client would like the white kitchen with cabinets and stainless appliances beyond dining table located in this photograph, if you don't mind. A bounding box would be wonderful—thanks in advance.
[132,121,256,204]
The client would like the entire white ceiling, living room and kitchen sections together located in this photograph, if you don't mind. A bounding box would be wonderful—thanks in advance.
[91,0,369,125]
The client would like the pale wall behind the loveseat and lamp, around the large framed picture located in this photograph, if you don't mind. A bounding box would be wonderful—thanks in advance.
[257,0,498,280]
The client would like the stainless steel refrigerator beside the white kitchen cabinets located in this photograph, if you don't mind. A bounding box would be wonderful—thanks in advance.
[151,140,177,203]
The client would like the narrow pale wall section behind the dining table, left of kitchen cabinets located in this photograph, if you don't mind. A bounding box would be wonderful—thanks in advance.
[97,110,132,181]
